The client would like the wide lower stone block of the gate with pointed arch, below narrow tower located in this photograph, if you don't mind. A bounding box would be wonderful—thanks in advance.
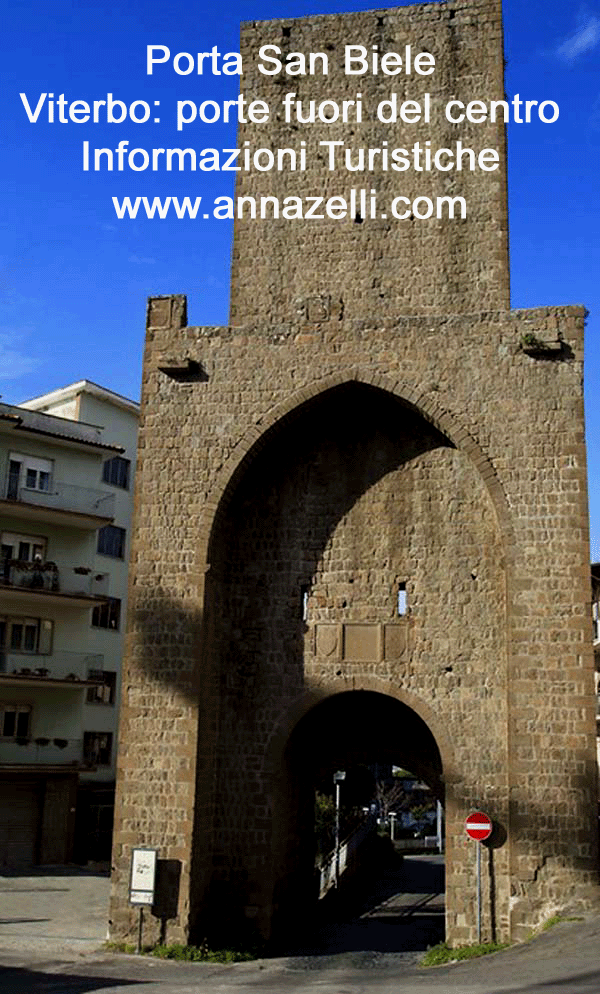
[113,298,596,942]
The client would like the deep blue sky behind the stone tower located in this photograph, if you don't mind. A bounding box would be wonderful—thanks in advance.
[0,0,600,560]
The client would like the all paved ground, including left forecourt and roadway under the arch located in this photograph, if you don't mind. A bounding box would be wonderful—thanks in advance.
[0,858,600,994]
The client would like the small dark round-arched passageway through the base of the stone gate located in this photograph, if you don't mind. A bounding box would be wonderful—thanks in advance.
[272,690,444,955]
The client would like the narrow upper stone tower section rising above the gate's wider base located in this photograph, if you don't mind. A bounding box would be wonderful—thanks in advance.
[230,0,509,324]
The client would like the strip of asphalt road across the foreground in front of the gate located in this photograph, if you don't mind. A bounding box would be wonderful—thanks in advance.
[0,918,600,994]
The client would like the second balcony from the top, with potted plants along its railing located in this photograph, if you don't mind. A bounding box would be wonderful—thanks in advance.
[0,559,108,608]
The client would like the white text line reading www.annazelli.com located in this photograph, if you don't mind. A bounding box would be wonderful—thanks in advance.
[112,188,467,222]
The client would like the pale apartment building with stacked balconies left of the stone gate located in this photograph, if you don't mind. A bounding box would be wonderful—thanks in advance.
[0,380,139,868]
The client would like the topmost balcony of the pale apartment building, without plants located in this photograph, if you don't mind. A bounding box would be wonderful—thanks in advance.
[0,475,115,529]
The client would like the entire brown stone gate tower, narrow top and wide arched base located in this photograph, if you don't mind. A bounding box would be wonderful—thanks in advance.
[111,0,596,943]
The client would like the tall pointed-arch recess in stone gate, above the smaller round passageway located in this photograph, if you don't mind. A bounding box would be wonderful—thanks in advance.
[194,381,506,935]
